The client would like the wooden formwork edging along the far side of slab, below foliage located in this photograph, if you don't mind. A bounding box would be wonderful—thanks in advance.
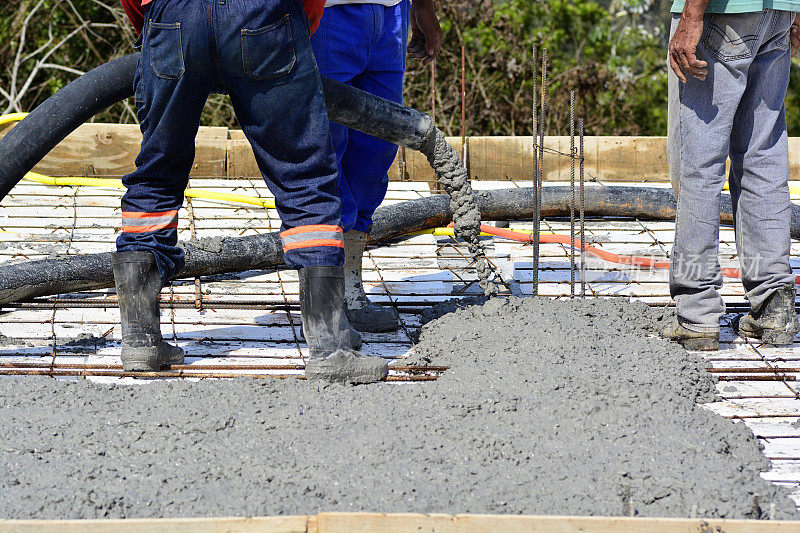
[0,124,780,184]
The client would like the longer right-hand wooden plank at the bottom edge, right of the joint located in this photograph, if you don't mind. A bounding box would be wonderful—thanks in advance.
[317,513,800,533]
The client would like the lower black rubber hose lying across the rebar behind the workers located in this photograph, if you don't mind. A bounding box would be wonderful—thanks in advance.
[0,186,800,305]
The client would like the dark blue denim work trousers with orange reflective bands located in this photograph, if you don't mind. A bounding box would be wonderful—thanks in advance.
[117,0,344,281]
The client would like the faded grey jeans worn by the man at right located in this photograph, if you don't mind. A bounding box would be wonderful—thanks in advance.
[667,9,795,331]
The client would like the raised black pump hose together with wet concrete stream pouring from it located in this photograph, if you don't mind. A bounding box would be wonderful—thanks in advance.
[0,54,497,295]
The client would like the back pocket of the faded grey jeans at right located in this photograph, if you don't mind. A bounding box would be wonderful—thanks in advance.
[703,11,767,61]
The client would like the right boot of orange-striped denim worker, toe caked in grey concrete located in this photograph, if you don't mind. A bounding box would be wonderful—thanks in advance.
[299,266,389,383]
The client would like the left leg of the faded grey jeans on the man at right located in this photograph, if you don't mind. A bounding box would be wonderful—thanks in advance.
[669,12,766,334]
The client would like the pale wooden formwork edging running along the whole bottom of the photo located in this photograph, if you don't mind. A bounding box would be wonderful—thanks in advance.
[0,513,800,533]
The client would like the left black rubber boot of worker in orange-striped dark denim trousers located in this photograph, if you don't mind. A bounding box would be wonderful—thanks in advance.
[111,252,183,372]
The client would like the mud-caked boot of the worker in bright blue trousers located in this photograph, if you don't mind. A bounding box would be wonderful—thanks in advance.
[344,230,400,333]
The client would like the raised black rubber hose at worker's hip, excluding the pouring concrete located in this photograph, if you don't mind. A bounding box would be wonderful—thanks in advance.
[0,54,434,200]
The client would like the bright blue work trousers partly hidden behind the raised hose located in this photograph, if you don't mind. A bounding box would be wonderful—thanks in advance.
[311,0,410,232]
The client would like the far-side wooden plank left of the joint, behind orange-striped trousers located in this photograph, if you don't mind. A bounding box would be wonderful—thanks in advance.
[24,124,228,176]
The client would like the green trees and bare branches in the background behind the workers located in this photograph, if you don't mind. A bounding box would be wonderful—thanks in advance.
[0,0,800,135]
